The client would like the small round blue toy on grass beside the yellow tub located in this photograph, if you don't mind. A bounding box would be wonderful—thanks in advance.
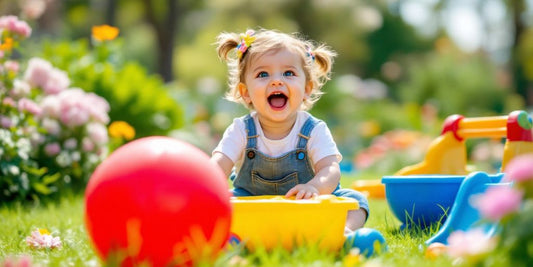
[344,228,387,258]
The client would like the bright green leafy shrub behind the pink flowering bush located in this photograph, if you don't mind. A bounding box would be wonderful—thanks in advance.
[38,40,183,137]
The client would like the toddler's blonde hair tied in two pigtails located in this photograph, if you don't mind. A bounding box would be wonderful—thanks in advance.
[216,29,336,110]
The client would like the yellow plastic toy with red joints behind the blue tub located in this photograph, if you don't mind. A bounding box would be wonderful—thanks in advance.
[351,110,533,198]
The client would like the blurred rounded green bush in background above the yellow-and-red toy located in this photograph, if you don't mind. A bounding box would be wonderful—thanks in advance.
[398,41,512,117]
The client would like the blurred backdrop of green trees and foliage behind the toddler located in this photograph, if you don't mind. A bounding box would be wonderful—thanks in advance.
[0,0,533,176]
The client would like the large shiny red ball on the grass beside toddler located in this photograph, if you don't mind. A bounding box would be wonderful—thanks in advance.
[85,137,231,266]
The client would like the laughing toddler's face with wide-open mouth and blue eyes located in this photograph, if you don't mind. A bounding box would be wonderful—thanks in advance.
[239,49,312,122]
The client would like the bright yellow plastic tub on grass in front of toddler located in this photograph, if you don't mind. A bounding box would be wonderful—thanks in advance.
[231,195,359,251]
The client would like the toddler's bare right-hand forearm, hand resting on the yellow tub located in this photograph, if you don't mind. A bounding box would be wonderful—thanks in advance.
[285,155,341,199]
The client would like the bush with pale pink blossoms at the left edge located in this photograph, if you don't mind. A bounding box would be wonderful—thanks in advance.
[0,16,109,201]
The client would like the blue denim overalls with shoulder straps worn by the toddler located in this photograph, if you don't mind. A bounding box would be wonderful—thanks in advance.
[233,115,318,196]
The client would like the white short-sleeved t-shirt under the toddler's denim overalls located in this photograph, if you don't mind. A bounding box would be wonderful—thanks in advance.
[213,111,342,173]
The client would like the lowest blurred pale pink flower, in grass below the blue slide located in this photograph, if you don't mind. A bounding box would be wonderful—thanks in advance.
[447,228,496,260]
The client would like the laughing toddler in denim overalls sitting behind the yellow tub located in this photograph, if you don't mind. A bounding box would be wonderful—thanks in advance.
[211,29,369,233]
